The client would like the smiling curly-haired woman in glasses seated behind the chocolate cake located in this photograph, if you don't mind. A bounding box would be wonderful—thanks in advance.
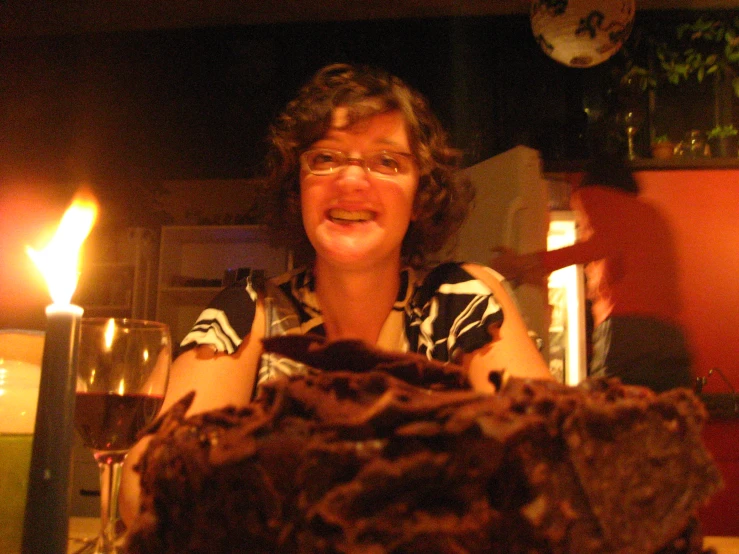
[121,65,549,519]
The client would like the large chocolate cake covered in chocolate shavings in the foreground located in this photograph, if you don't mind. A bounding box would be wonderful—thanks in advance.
[127,337,720,554]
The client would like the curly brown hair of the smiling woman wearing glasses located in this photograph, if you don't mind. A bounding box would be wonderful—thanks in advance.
[265,64,473,266]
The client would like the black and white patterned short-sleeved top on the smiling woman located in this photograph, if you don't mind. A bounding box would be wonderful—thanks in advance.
[180,263,503,390]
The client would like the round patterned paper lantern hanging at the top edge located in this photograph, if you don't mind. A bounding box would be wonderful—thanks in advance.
[531,0,636,67]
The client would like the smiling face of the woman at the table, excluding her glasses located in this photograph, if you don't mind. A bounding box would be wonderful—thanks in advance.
[300,108,418,268]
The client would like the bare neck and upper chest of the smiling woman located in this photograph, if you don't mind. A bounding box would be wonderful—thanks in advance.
[314,261,400,345]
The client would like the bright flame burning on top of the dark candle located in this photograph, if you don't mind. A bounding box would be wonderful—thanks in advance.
[26,194,97,304]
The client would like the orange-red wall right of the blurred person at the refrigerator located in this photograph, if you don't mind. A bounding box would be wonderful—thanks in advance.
[635,169,739,392]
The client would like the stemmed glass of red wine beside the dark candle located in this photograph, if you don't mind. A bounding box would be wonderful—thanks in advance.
[74,318,172,554]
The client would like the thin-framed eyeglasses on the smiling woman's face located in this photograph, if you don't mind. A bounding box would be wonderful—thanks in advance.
[300,148,415,177]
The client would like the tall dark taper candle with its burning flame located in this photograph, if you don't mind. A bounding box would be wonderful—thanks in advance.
[22,192,97,554]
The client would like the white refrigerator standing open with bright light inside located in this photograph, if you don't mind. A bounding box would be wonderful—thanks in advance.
[452,146,586,384]
